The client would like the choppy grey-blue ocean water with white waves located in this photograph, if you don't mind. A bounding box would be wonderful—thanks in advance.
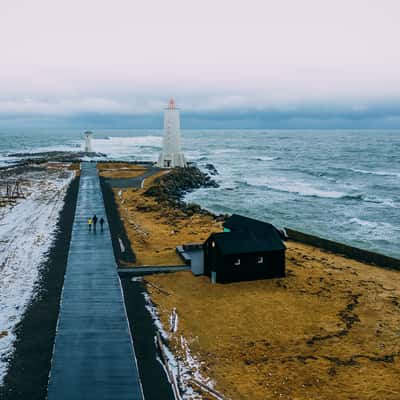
[0,129,400,258]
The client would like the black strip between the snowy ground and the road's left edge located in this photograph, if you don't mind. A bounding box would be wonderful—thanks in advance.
[0,167,79,400]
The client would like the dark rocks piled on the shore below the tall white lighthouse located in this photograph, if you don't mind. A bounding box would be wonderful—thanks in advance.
[144,166,219,215]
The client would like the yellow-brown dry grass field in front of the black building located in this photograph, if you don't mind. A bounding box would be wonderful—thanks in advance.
[146,242,400,400]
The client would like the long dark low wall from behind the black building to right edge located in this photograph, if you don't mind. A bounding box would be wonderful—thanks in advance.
[285,228,400,270]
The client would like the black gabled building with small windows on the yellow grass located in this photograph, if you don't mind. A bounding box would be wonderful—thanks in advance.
[203,214,286,283]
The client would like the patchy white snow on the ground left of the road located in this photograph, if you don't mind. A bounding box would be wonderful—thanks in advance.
[0,167,75,386]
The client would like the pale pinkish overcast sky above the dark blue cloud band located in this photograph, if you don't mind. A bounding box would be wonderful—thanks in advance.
[0,0,400,125]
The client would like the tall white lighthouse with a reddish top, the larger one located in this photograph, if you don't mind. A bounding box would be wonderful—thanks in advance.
[157,99,187,168]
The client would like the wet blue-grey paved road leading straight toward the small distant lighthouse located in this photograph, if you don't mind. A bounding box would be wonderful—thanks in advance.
[48,163,143,400]
